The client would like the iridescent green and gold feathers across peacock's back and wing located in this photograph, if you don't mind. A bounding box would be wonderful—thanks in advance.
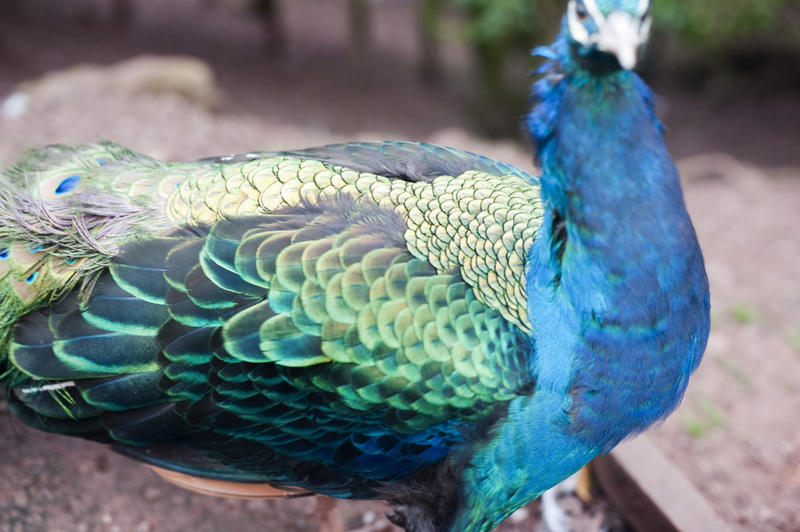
[0,140,538,493]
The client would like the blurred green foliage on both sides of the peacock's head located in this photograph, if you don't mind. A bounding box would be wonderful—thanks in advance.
[440,0,800,135]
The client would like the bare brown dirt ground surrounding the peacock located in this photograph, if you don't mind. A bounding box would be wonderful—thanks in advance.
[0,0,800,532]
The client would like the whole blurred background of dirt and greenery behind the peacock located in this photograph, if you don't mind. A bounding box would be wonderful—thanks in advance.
[0,0,800,532]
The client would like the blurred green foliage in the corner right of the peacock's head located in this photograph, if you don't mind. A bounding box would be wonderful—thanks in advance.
[653,0,800,49]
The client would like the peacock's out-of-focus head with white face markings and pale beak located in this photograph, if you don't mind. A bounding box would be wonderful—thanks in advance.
[565,0,652,71]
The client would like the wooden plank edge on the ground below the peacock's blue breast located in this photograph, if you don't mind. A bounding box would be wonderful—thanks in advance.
[592,434,731,532]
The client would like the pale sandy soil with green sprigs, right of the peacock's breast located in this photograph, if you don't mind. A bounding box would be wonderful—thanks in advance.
[656,156,800,531]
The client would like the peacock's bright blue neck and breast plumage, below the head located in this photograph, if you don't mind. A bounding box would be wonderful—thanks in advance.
[452,30,709,530]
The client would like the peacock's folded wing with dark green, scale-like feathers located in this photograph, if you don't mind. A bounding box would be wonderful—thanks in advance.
[10,195,531,495]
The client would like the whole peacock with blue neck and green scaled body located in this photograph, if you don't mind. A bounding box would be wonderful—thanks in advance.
[0,0,709,532]
